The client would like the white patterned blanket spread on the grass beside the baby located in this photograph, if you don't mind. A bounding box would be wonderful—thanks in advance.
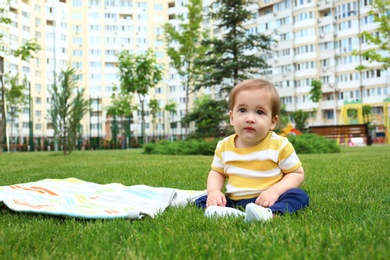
[0,178,206,219]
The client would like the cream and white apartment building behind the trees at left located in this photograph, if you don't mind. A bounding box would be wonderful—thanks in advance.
[0,0,178,146]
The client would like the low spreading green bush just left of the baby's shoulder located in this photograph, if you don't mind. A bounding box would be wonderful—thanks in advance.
[144,139,219,155]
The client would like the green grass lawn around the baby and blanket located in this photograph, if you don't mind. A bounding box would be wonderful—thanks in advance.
[0,146,390,259]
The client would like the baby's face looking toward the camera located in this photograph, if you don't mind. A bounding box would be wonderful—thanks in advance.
[230,89,278,148]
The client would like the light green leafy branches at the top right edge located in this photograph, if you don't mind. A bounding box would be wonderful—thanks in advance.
[352,0,390,70]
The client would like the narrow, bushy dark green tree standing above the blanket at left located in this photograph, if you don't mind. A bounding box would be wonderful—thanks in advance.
[47,68,89,155]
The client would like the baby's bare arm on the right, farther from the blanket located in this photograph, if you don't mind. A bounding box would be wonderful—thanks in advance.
[255,167,305,208]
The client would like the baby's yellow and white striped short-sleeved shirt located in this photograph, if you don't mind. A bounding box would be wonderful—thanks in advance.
[211,131,302,200]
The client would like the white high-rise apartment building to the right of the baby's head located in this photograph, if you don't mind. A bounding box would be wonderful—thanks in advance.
[257,0,390,125]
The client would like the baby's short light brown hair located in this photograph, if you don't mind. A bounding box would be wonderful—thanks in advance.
[229,79,280,116]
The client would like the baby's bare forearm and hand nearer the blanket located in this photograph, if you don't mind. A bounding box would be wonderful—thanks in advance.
[206,170,226,207]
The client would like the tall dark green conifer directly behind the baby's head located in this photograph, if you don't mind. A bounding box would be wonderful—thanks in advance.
[196,0,273,96]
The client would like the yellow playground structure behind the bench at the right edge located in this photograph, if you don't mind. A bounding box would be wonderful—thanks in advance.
[338,98,390,144]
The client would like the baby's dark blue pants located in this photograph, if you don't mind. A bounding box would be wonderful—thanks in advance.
[195,188,309,214]
